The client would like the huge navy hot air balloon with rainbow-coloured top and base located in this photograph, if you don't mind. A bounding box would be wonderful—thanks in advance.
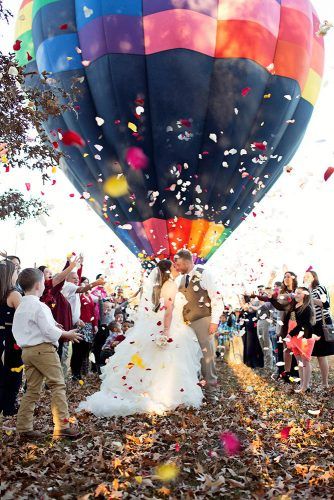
[16,0,324,262]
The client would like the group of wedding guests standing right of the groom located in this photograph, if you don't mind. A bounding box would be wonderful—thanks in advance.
[216,269,334,393]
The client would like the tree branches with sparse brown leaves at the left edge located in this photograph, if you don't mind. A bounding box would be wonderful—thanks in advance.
[0,0,79,220]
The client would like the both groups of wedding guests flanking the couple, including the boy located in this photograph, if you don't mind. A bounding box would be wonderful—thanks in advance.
[0,255,334,437]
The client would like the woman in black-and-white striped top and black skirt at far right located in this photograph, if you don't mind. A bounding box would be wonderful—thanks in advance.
[304,271,334,389]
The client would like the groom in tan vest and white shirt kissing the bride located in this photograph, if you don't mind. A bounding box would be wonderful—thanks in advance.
[174,249,224,402]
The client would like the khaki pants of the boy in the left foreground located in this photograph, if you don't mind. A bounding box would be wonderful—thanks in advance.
[16,344,69,433]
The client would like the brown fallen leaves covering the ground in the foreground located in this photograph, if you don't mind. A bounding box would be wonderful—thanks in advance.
[1,362,334,500]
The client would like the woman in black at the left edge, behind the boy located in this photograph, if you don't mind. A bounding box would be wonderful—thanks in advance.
[0,257,23,417]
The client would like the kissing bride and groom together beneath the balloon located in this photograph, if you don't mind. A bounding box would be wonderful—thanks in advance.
[79,249,223,417]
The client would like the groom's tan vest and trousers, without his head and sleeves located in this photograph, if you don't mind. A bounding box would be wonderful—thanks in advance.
[179,267,219,392]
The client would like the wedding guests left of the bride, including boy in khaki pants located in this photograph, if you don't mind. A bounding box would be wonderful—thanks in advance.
[0,254,140,437]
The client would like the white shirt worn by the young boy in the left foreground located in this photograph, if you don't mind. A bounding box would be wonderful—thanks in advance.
[13,295,64,348]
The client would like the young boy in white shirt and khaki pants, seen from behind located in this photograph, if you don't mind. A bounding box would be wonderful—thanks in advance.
[13,269,82,439]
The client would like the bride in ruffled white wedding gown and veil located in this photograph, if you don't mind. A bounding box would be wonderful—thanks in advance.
[79,259,203,417]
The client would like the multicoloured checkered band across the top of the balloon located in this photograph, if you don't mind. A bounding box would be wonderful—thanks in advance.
[16,0,324,104]
